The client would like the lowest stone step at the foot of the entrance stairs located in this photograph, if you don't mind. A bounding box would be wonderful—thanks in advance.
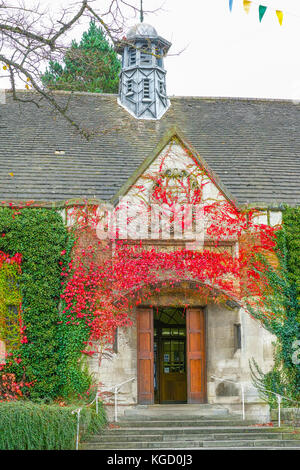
[82,439,300,450]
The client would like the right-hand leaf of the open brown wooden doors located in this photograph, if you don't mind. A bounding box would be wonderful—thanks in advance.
[186,308,206,403]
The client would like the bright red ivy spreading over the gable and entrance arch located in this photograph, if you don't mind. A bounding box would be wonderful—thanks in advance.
[62,151,278,355]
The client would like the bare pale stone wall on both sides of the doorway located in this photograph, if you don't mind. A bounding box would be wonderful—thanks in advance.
[90,294,274,422]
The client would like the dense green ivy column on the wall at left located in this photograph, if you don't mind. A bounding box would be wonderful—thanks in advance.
[0,207,68,399]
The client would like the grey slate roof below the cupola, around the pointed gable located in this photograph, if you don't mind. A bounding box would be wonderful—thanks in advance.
[0,92,300,206]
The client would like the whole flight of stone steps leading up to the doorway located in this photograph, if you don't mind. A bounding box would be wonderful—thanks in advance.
[82,405,300,450]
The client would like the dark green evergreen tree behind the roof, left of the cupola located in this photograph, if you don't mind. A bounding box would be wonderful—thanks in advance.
[42,21,121,93]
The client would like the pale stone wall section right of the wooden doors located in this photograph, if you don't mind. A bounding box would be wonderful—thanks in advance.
[207,305,275,421]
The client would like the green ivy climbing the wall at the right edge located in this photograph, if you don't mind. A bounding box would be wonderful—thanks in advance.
[249,206,300,408]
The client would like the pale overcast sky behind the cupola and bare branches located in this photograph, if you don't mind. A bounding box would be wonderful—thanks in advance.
[0,0,300,99]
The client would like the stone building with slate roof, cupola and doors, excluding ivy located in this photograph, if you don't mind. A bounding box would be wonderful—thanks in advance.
[0,24,300,420]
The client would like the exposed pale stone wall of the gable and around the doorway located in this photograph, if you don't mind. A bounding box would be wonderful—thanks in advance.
[84,138,281,420]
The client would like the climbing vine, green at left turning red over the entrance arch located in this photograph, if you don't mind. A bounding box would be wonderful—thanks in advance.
[0,141,292,399]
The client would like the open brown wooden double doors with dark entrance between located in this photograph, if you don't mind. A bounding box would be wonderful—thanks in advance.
[137,308,206,404]
